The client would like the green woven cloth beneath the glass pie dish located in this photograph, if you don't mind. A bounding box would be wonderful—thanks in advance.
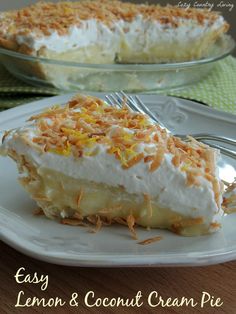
[0,56,236,113]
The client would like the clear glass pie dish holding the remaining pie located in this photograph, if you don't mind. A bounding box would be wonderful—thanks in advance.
[0,35,235,92]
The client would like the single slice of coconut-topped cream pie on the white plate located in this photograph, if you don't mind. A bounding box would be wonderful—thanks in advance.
[1,95,223,235]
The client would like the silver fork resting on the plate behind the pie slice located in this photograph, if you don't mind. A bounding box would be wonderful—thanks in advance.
[105,91,236,159]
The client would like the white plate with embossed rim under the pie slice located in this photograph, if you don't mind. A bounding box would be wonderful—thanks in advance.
[0,94,236,266]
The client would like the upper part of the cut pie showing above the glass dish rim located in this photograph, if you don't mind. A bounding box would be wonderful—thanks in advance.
[0,0,229,64]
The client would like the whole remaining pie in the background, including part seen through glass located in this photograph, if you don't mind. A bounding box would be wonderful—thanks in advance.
[0,0,229,92]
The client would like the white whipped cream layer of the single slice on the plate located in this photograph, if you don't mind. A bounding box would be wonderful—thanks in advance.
[0,125,223,224]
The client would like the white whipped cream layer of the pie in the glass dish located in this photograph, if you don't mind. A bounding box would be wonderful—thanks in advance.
[14,15,225,54]
